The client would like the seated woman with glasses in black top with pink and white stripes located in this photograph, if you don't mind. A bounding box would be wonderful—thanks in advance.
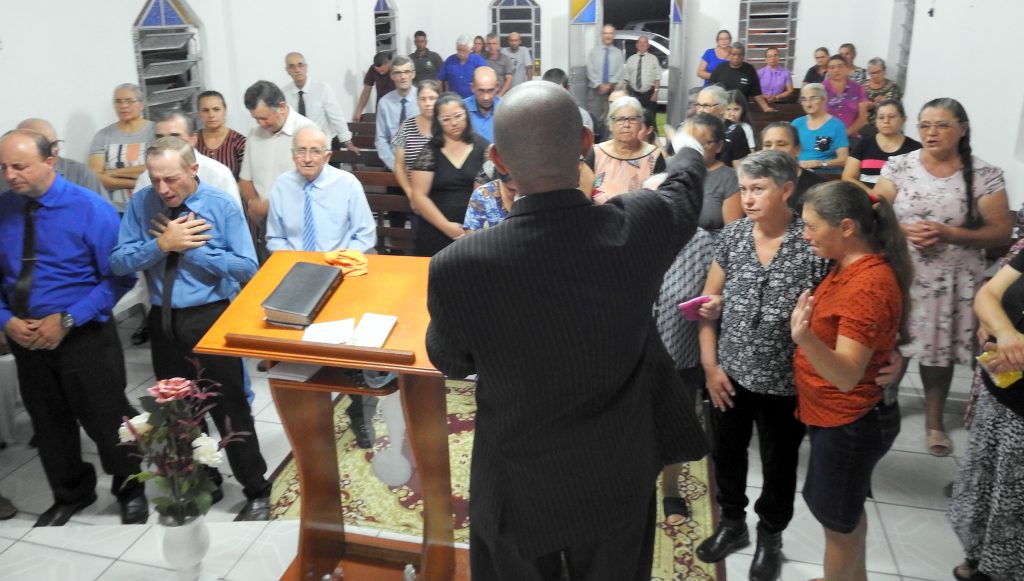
[843,100,921,192]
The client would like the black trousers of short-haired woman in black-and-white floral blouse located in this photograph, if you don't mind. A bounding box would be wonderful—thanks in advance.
[712,378,807,533]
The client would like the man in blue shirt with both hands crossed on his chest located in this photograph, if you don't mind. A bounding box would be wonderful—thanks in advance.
[111,136,270,521]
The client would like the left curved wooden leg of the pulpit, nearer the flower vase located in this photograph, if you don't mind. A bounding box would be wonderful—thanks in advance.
[270,379,348,580]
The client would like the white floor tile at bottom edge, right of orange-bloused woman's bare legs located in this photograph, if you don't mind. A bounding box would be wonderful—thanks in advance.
[879,504,964,579]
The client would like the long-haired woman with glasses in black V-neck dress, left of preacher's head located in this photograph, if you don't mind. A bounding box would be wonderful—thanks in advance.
[410,92,490,256]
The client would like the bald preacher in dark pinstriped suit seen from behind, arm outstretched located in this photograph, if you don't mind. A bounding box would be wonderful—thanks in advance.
[427,81,706,581]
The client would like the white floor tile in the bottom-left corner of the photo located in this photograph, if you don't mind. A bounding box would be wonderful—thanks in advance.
[0,541,114,581]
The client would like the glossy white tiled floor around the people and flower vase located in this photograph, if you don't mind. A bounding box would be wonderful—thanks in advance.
[0,318,970,581]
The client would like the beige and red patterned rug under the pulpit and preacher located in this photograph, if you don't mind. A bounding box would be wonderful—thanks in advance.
[270,381,716,581]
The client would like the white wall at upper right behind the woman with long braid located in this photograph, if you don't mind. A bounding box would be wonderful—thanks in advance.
[904,0,1024,210]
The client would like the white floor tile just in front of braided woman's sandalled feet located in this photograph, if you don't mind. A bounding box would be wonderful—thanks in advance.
[871,450,957,510]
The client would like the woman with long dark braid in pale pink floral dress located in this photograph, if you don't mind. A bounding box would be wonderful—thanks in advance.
[874,98,1013,456]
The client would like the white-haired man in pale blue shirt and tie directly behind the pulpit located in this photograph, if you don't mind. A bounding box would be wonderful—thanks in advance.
[266,127,377,448]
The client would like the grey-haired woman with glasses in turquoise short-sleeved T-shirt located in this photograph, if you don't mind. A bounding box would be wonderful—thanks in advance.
[793,83,850,173]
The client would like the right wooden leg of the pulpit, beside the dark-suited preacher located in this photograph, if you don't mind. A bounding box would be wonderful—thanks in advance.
[399,374,455,581]
